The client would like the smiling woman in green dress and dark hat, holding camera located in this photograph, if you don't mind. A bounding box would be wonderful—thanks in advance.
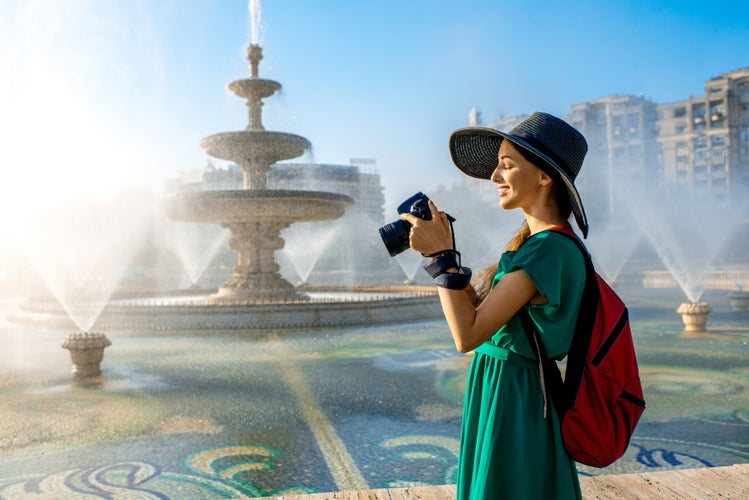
[402,113,588,500]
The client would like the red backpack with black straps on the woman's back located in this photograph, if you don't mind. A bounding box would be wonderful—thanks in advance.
[520,228,645,467]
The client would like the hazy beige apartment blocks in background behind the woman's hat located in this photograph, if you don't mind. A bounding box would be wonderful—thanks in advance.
[469,68,749,214]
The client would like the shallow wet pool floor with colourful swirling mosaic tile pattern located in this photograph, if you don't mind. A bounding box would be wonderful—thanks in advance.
[0,290,749,499]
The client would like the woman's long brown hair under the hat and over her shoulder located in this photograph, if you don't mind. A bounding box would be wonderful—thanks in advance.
[473,143,572,305]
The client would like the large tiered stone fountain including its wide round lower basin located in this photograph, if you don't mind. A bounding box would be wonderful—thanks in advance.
[9,2,442,332]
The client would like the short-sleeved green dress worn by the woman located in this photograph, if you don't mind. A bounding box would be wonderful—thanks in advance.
[457,231,585,500]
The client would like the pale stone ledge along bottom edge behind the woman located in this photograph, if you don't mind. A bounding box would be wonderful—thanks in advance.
[266,464,749,500]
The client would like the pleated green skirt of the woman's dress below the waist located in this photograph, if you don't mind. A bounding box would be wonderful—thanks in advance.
[457,343,582,500]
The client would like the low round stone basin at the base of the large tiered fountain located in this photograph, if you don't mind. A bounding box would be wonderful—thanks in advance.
[8,286,442,335]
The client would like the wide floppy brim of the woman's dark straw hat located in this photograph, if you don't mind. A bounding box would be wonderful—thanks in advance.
[450,127,588,237]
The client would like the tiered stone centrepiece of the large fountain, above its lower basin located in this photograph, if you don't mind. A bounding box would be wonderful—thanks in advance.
[165,44,353,302]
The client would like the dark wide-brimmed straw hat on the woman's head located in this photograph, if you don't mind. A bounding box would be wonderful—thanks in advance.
[450,112,588,238]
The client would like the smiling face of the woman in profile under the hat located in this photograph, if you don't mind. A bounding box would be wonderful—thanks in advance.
[491,140,550,210]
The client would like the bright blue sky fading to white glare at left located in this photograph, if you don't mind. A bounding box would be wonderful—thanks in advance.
[0,0,749,230]
